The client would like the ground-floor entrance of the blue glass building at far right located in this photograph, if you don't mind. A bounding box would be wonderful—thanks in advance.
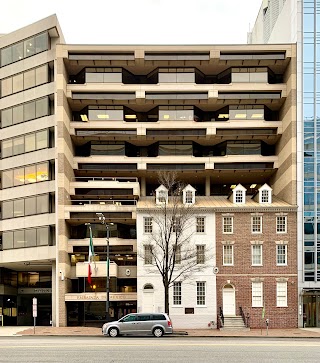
[303,291,320,328]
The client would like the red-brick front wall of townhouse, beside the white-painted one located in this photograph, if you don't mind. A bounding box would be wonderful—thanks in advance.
[216,210,298,328]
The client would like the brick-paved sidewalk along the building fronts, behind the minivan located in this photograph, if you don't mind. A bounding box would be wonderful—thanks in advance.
[0,326,320,339]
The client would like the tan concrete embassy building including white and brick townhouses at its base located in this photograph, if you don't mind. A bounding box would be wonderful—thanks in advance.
[0,16,298,327]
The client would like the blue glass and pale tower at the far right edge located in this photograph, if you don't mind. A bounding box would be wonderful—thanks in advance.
[248,0,320,327]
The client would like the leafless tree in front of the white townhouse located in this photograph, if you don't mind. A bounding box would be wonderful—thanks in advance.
[140,172,208,314]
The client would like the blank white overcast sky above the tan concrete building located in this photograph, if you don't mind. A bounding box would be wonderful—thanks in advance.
[0,0,262,44]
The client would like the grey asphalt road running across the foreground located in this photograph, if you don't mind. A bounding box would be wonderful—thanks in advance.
[0,336,320,363]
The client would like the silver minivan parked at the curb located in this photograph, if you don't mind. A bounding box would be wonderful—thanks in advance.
[102,313,172,337]
